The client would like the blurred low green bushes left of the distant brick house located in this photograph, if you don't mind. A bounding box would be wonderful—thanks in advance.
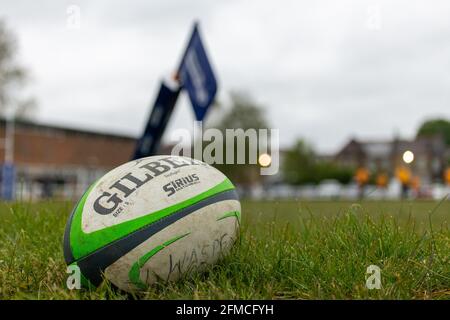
[282,140,354,184]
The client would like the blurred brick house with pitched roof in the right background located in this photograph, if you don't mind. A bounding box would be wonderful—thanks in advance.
[334,136,450,183]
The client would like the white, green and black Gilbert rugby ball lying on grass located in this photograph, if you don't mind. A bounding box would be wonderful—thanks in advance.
[64,156,241,292]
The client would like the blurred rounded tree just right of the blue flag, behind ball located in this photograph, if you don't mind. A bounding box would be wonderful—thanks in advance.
[209,92,268,188]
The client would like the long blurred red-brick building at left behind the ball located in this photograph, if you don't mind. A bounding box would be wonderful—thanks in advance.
[0,120,135,199]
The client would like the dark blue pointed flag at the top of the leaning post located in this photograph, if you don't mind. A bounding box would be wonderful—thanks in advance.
[178,24,217,121]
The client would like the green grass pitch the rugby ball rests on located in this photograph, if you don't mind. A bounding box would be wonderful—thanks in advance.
[0,201,450,299]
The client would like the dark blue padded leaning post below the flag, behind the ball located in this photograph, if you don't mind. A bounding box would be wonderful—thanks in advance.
[133,83,180,159]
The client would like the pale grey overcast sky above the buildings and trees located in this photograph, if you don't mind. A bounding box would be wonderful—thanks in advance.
[0,0,450,152]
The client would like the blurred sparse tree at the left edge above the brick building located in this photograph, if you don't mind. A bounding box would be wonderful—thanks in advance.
[0,20,34,118]
